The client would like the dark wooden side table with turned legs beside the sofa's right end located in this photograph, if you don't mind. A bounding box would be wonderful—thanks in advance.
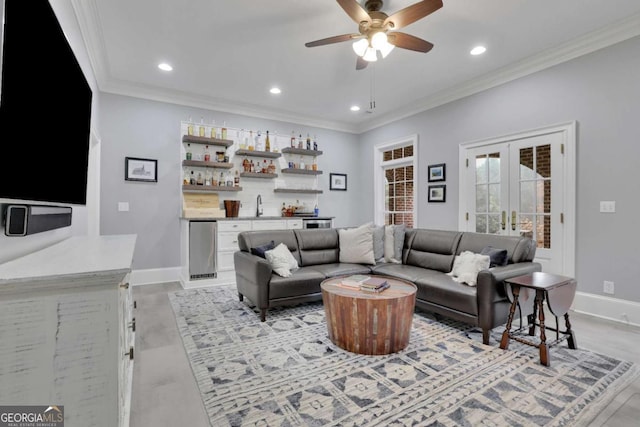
[500,272,578,366]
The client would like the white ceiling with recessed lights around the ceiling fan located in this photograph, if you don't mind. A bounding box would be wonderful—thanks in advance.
[72,0,640,132]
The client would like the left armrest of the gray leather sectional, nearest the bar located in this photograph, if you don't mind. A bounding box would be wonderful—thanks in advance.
[233,251,273,309]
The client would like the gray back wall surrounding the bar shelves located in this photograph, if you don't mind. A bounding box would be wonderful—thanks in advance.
[100,94,362,269]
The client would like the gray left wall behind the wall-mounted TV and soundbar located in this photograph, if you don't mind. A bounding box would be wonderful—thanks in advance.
[0,0,100,263]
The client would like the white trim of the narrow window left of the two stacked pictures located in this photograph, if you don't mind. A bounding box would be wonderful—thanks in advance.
[373,134,418,227]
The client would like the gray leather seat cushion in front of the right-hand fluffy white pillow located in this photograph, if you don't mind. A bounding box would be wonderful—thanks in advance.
[413,270,478,316]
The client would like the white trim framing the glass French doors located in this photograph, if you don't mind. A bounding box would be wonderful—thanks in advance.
[458,120,577,277]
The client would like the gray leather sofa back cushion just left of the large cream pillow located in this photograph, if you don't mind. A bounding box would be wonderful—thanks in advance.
[294,228,339,266]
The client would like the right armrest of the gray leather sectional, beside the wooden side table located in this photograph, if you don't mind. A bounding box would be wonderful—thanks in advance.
[477,262,542,330]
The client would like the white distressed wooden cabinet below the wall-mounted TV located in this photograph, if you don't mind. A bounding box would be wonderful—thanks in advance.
[0,235,136,427]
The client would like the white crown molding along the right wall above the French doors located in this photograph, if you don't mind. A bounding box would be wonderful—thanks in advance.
[357,14,640,133]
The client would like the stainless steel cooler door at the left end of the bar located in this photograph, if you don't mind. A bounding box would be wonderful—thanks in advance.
[189,221,217,279]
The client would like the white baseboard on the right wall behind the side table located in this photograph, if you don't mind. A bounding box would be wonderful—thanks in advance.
[572,292,640,326]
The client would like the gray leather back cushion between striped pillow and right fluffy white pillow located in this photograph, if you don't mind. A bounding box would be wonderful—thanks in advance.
[406,229,462,273]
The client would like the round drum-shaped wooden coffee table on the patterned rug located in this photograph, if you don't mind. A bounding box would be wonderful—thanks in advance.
[320,276,417,355]
